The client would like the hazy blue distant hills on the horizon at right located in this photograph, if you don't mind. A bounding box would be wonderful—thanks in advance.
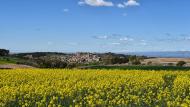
[123,51,190,58]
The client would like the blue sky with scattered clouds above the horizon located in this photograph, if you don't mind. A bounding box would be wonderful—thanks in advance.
[0,0,190,52]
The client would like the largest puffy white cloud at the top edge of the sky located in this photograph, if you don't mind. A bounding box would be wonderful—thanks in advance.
[78,0,114,7]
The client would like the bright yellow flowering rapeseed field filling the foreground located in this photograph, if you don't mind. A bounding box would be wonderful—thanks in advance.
[0,69,190,107]
